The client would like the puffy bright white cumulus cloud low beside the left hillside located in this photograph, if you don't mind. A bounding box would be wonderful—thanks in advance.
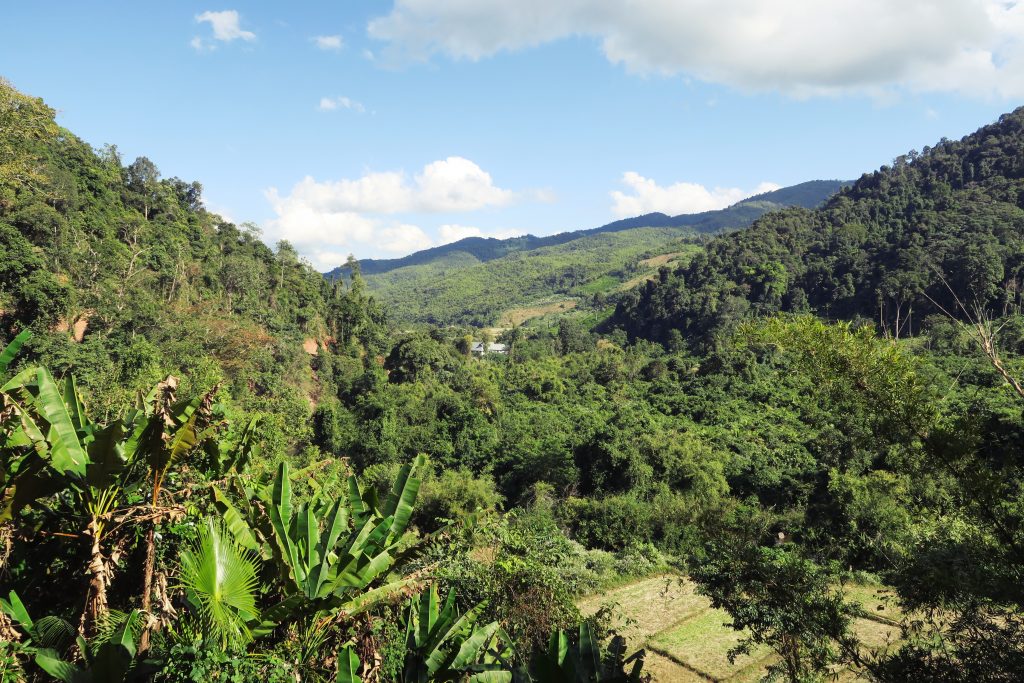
[264,157,517,269]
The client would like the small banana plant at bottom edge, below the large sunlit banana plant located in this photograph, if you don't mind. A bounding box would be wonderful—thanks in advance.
[401,585,513,683]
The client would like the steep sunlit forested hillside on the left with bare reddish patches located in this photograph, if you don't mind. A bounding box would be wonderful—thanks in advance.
[0,81,382,450]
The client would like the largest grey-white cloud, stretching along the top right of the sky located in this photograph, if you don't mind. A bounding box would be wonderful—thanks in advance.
[368,0,1024,97]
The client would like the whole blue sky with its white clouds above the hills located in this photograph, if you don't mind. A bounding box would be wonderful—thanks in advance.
[0,0,1024,269]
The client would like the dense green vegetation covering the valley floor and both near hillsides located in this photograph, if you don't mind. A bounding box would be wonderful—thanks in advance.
[0,76,1024,682]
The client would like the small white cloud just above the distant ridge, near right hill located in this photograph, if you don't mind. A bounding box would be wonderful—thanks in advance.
[611,171,779,218]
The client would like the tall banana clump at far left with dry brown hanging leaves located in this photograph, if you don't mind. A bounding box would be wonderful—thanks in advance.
[0,362,233,649]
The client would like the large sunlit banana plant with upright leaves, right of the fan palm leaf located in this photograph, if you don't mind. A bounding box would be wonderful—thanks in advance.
[213,456,426,636]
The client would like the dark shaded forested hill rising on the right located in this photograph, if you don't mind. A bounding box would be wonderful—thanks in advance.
[612,109,1024,350]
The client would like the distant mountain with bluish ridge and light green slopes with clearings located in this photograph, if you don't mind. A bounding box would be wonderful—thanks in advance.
[327,180,844,326]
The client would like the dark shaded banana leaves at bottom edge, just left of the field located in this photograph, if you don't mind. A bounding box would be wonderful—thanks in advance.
[516,622,650,683]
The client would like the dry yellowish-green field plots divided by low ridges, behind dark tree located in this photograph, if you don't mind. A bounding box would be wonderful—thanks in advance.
[580,575,901,683]
